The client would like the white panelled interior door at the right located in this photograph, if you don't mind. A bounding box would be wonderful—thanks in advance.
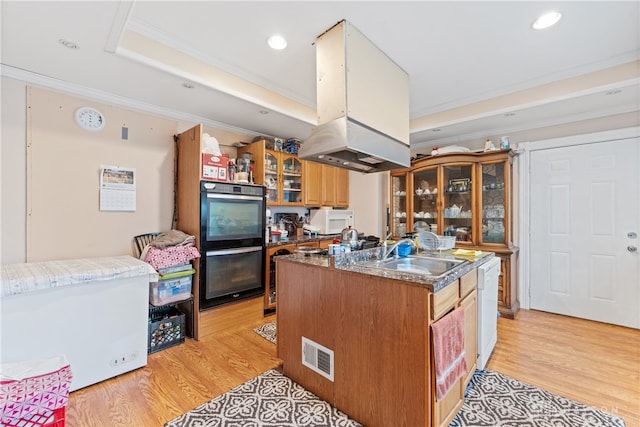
[529,138,640,328]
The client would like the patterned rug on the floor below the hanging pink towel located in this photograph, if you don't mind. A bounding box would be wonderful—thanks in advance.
[450,370,625,427]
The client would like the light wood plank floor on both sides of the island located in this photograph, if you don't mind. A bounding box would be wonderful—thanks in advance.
[66,299,640,427]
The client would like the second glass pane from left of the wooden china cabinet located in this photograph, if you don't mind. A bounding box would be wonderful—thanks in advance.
[411,167,441,233]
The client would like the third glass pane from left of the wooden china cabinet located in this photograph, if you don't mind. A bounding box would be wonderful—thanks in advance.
[442,164,474,242]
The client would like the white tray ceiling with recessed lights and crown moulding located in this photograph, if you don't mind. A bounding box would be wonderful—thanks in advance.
[1,0,640,153]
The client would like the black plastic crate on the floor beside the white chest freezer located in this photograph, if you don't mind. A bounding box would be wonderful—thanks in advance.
[147,306,185,354]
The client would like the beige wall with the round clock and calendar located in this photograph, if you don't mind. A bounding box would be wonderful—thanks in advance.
[0,77,253,263]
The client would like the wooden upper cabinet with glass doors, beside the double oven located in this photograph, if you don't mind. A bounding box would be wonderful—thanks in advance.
[238,140,304,206]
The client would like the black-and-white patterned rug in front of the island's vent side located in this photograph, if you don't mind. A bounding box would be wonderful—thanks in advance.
[165,369,362,427]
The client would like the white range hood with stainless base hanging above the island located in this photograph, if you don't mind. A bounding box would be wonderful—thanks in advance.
[298,20,411,173]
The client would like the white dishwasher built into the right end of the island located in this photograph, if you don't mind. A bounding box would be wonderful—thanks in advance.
[478,257,500,369]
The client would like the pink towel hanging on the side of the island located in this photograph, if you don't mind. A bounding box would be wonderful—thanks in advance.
[431,307,467,400]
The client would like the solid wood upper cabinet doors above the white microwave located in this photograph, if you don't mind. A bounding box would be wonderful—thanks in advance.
[304,161,349,208]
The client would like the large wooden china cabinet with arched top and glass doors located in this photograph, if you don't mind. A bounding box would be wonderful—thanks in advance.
[389,150,520,319]
